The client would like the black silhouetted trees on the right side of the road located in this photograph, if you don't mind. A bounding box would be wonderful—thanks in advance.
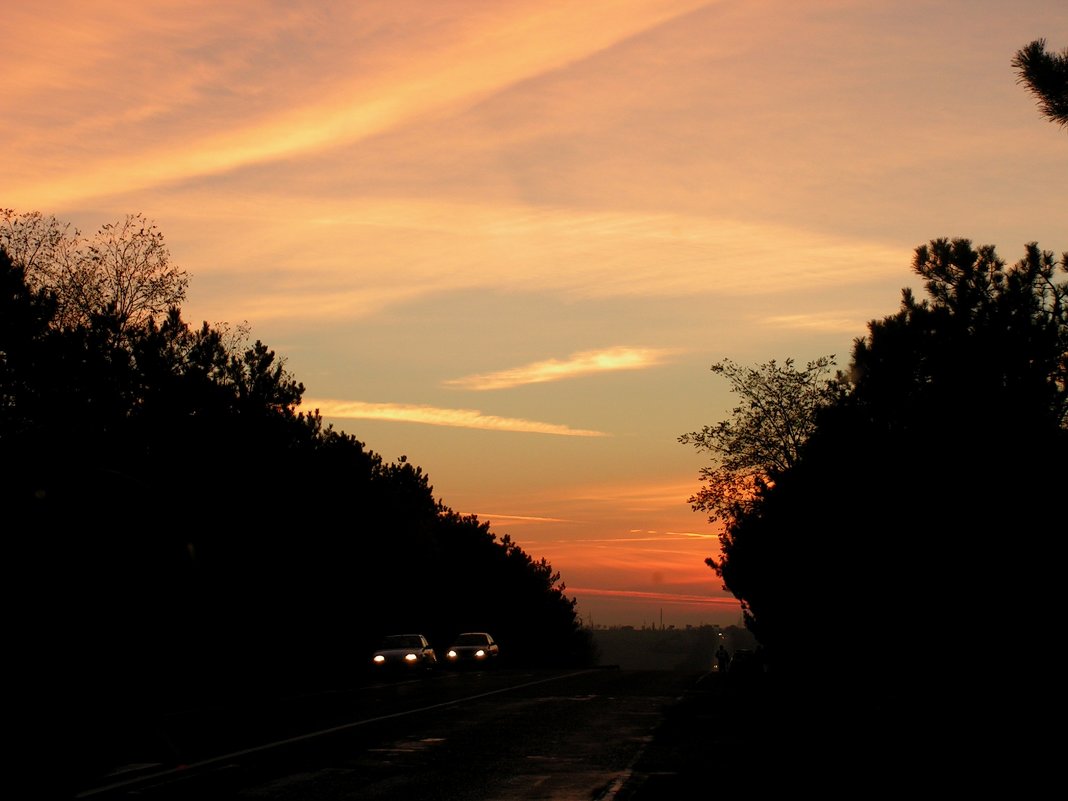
[680,239,1068,773]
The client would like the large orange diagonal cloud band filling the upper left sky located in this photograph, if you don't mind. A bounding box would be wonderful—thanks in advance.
[6,0,705,207]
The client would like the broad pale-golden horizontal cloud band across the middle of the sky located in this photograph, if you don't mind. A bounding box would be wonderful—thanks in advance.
[170,192,906,326]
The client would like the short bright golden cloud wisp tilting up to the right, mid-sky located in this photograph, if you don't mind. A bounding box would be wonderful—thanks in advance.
[444,346,675,391]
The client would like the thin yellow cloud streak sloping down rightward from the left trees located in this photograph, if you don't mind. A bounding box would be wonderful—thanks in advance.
[301,398,609,437]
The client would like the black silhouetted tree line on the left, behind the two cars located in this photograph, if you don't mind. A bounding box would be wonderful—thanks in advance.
[0,226,592,786]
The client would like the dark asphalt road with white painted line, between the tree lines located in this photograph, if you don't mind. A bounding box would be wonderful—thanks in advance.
[76,669,717,801]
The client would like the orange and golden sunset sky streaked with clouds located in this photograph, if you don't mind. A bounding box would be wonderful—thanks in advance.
[0,0,1068,626]
